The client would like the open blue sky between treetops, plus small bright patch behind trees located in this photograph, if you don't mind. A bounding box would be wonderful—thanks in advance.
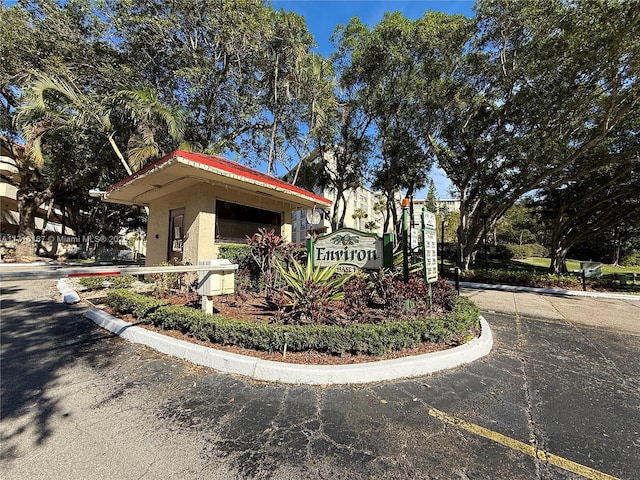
[272,0,474,198]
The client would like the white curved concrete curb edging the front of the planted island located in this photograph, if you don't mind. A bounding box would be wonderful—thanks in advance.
[84,308,493,385]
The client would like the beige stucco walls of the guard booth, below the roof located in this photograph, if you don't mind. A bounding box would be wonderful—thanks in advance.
[146,183,291,266]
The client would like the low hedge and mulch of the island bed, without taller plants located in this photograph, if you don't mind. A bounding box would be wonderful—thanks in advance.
[96,278,480,364]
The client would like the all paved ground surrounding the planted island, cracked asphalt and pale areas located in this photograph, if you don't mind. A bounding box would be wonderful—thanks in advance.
[0,281,640,480]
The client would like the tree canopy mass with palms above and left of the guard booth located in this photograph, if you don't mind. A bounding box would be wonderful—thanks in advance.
[0,0,335,255]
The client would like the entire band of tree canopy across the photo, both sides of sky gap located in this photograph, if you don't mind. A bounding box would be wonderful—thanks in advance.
[0,0,640,271]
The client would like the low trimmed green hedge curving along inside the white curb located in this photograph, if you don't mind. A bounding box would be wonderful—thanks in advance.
[106,290,480,356]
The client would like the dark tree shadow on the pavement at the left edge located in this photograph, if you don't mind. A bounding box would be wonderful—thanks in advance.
[0,282,113,460]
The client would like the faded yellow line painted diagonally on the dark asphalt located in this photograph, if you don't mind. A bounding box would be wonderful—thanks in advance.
[429,408,620,480]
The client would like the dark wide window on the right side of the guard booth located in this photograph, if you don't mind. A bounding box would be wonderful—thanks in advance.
[216,200,282,243]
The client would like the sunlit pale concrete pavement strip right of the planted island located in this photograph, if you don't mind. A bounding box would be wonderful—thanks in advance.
[460,286,640,335]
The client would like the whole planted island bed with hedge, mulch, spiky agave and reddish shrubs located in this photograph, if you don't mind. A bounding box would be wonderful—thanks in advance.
[75,244,480,364]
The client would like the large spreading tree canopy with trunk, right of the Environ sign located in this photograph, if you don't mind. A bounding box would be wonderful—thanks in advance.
[330,0,640,268]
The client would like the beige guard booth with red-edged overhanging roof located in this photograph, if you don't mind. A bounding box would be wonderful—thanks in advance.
[103,150,332,266]
